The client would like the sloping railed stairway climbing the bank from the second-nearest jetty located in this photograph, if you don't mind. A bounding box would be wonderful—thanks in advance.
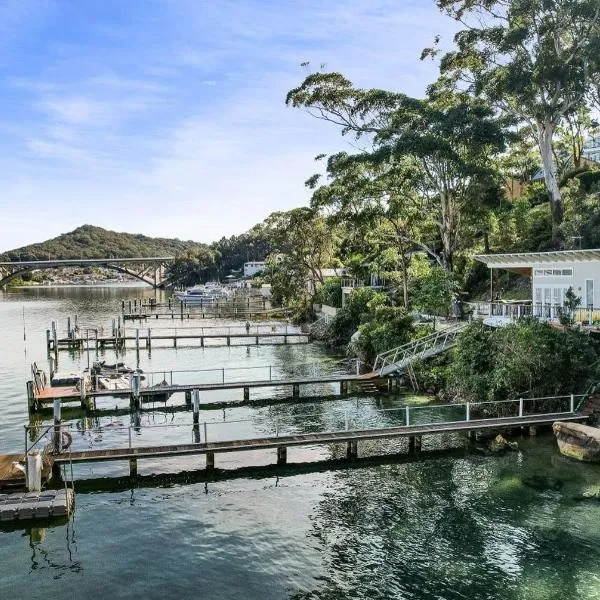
[373,323,466,377]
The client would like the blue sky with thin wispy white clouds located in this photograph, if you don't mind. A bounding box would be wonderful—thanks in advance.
[0,0,454,251]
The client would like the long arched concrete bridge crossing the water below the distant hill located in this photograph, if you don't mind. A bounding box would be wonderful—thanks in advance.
[0,256,174,288]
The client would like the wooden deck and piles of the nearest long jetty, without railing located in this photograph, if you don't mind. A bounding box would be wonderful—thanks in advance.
[54,411,587,476]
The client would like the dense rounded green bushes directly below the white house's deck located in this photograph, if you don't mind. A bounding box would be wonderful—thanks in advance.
[450,319,598,401]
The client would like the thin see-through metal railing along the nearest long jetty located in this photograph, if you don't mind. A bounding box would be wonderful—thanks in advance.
[39,394,582,452]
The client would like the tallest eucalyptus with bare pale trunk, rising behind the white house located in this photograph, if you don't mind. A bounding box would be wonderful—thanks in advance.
[434,0,600,240]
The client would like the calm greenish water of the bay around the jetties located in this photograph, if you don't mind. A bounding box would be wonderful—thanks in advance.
[0,288,600,600]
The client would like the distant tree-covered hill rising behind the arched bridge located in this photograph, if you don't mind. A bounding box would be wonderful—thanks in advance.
[0,225,203,261]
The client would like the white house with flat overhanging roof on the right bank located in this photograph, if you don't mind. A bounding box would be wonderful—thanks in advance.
[475,249,600,319]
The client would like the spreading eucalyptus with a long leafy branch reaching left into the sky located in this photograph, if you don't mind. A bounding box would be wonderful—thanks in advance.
[286,73,504,270]
